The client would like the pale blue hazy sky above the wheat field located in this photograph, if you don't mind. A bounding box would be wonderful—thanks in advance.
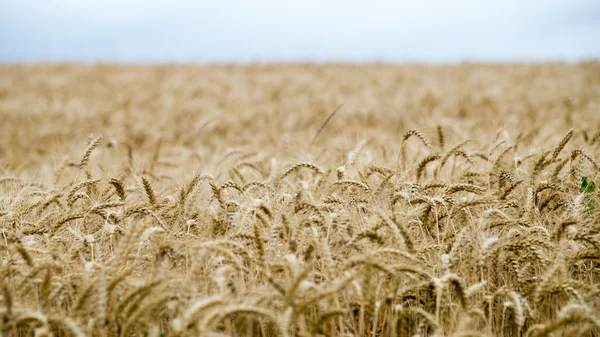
[0,0,600,63]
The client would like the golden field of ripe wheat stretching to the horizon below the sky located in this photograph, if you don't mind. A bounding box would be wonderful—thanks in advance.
[0,62,600,337]
